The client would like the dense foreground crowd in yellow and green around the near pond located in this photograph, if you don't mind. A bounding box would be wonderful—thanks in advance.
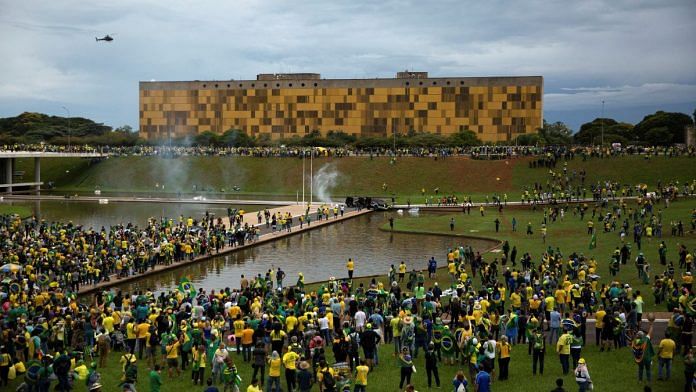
[0,199,696,392]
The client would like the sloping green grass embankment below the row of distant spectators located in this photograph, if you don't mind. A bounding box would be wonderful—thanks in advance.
[17,156,696,203]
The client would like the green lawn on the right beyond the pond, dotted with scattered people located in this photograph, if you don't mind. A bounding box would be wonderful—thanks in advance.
[382,199,696,311]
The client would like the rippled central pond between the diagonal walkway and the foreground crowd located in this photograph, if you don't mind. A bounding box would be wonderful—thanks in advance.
[111,213,495,291]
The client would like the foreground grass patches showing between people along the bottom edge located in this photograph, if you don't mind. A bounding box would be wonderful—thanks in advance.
[6,336,684,392]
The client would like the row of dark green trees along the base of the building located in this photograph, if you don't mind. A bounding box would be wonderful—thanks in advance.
[0,110,696,148]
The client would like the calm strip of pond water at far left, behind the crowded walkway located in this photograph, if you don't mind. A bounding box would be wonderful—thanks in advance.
[2,200,266,229]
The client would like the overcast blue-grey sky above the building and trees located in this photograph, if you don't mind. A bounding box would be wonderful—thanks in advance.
[0,0,696,130]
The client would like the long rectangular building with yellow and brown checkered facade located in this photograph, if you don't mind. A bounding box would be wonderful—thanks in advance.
[140,71,544,142]
